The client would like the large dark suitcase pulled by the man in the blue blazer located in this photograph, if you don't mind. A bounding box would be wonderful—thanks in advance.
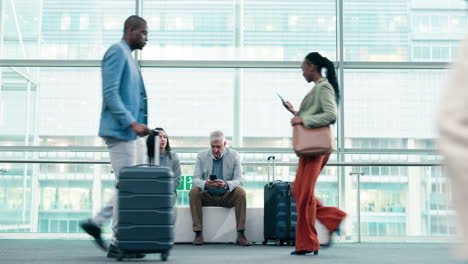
[116,131,175,261]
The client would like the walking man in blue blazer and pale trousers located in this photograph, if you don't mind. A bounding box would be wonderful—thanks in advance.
[81,16,151,258]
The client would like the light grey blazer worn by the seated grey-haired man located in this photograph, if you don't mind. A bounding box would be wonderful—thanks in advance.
[192,148,243,192]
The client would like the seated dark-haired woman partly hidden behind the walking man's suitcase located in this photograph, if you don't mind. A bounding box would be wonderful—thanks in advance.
[146,127,181,192]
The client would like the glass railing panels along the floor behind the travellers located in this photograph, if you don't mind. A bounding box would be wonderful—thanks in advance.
[0,148,455,242]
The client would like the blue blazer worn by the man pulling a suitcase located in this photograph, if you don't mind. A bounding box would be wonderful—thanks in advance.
[99,40,148,140]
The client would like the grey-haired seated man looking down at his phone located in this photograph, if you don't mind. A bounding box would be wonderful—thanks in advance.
[189,131,250,246]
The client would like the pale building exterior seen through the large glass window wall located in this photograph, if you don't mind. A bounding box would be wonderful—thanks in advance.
[0,0,467,240]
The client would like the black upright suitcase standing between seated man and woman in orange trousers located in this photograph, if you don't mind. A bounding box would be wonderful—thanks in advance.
[262,156,297,246]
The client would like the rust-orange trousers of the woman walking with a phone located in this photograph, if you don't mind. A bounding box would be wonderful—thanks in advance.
[293,155,346,251]
